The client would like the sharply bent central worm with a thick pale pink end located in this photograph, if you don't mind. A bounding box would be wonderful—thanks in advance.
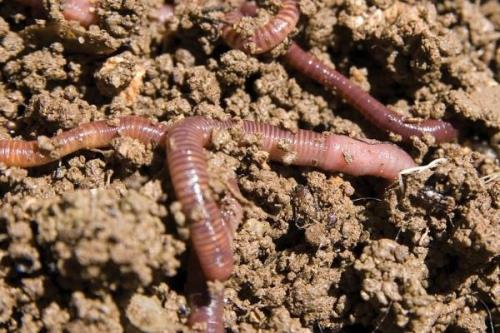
[166,117,415,281]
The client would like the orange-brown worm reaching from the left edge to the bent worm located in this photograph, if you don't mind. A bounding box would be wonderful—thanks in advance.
[0,116,166,168]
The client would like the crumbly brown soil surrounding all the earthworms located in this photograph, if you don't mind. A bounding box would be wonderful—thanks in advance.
[0,0,500,333]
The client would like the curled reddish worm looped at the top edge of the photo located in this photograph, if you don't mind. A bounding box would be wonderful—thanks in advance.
[221,0,300,54]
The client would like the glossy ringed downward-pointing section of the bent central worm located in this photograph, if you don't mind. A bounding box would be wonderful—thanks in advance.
[167,117,233,281]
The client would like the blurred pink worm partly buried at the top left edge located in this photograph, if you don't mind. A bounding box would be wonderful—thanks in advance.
[17,0,97,27]
